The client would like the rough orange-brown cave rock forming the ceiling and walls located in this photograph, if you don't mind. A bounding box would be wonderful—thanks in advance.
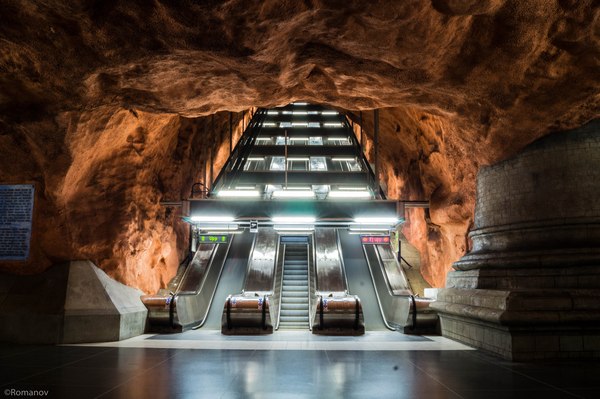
[0,0,600,291]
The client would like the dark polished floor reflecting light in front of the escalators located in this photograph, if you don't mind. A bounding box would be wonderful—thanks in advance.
[0,331,600,399]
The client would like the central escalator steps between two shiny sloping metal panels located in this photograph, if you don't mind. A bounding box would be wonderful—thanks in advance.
[279,244,309,330]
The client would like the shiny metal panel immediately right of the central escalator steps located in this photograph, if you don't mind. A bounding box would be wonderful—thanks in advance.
[315,228,347,293]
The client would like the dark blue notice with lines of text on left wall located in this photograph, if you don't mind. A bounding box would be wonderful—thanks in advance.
[0,184,35,261]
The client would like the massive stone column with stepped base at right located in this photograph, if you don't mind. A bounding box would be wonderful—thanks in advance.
[432,120,600,360]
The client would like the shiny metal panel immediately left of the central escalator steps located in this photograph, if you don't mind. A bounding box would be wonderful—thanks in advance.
[244,228,279,292]
